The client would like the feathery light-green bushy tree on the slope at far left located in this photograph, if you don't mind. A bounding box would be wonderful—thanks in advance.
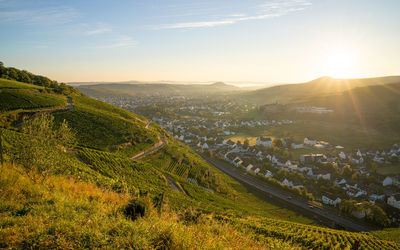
[15,114,76,182]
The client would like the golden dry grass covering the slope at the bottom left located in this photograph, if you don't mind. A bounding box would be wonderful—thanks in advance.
[0,165,291,249]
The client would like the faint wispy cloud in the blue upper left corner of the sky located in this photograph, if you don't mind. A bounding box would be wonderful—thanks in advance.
[0,6,78,24]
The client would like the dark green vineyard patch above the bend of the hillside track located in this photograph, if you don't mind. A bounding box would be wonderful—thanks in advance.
[55,95,157,150]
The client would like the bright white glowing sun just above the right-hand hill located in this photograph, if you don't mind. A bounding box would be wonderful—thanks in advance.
[325,51,355,78]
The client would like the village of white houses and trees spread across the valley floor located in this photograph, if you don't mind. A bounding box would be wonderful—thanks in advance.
[101,96,400,226]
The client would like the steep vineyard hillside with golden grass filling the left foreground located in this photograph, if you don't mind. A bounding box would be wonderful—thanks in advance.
[0,74,397,249]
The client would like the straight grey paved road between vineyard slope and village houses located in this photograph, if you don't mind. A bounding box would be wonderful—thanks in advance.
[204,157,377,232]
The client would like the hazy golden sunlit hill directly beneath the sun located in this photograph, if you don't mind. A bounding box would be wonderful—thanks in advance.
[238,76,400,104]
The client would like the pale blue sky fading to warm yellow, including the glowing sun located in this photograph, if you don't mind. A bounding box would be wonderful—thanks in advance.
[0,0,400,83]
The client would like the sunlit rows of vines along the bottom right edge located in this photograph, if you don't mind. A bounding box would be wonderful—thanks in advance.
[217,216,399,249]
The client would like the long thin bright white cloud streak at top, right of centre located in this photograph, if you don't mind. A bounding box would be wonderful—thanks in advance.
[155,0,312,29]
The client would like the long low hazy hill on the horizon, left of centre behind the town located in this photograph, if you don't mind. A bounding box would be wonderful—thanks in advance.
[77,82,243,98]
